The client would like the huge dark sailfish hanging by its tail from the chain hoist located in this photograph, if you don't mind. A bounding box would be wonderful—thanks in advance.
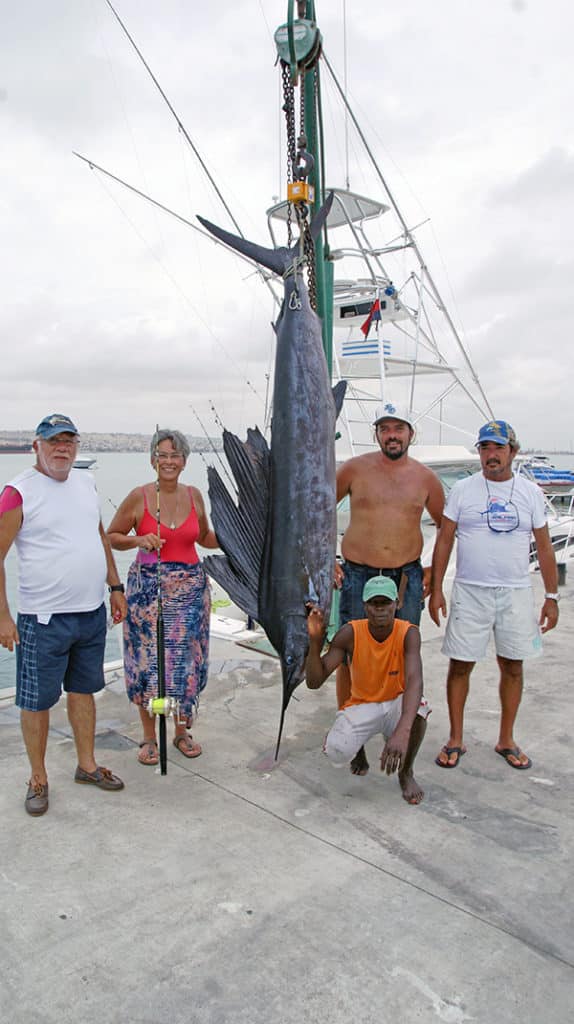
[198,194,346,759]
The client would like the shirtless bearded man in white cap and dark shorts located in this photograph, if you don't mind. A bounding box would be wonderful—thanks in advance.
[337,402,444,775]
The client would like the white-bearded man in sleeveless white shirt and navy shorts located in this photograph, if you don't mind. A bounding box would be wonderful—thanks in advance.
[0,413,127,816]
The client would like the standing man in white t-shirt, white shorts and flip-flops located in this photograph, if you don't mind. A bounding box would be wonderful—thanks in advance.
[429,420,559,770]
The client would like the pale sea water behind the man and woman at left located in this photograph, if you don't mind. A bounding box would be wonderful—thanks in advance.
[0,452,214,689]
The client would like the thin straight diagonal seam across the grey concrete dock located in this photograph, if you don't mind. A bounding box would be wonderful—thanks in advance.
[162,765,574,968]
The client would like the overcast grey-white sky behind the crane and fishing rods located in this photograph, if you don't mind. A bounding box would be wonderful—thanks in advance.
[0,0,574,447]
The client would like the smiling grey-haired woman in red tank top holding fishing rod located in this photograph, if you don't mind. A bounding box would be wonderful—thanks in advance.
[107,430,218,765]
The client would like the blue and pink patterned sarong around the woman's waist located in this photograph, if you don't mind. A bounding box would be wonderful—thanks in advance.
[124,562,211,716]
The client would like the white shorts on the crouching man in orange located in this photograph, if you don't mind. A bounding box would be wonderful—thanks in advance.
[323,693,432,765]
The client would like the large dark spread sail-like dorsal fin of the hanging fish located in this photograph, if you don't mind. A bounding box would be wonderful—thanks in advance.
[204,428,270,618]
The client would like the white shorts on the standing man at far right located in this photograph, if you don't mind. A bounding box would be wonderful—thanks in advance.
[441,583,542,662]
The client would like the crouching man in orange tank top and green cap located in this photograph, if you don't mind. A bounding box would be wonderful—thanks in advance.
[306,575,431,804]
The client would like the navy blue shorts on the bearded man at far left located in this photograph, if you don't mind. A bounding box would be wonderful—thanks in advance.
[15,604,106,711]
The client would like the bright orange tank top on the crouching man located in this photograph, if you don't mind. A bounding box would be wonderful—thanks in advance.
[343,618,416,708]
